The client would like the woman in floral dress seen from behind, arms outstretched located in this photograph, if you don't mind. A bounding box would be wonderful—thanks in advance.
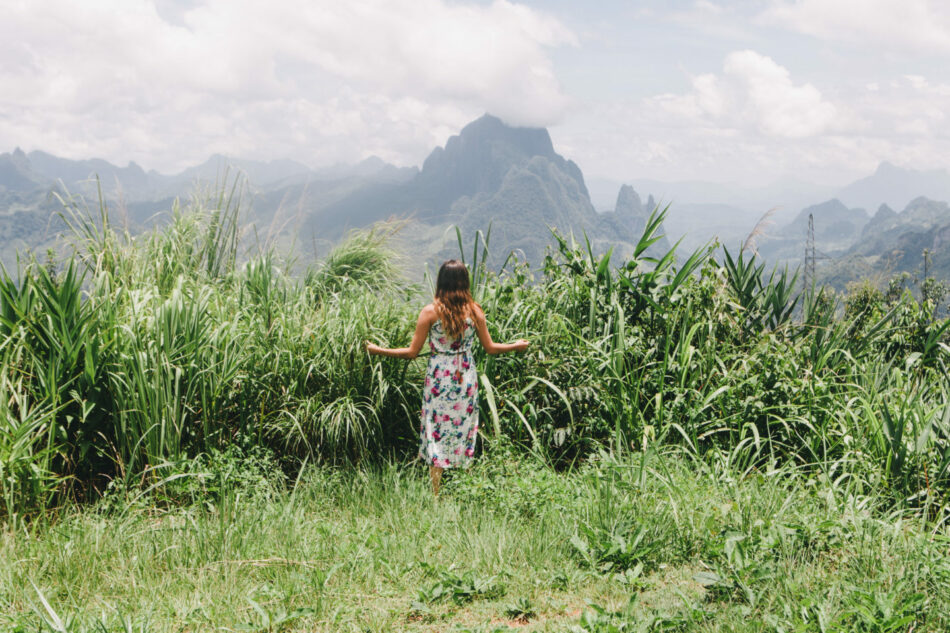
[366,259,528,494]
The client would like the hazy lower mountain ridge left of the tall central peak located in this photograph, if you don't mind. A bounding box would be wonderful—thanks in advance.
[0,148,418,267]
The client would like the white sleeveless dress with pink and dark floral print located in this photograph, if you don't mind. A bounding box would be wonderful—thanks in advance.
[419,319,478,468]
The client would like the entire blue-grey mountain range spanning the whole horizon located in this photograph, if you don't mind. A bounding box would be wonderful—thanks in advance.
[0,126,950,284]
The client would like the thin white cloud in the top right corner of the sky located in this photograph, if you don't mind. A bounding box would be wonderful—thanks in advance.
[760,0,950,52]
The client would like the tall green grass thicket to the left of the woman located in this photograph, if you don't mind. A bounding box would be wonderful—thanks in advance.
[0,182,418,519]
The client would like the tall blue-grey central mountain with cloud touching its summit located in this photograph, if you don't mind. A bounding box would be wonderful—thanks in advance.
[302,114,642,264]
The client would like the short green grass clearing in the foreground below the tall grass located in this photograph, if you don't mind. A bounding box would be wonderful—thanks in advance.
[0,450,950,632]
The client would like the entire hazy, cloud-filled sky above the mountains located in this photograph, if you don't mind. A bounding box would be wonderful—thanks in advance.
[0,0,950,184]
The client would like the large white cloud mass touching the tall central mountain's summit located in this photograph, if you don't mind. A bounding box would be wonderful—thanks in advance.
[0,0,576,170]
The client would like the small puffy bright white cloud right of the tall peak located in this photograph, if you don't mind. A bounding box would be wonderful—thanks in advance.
[651,50,839,138]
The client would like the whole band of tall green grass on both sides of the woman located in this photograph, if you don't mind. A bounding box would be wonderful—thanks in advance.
[0,182,950,521]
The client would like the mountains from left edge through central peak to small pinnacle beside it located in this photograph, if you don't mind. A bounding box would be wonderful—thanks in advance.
[0,114,668,272]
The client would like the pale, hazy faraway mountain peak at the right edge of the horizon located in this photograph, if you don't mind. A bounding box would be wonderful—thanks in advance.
[837,162,950,209]
